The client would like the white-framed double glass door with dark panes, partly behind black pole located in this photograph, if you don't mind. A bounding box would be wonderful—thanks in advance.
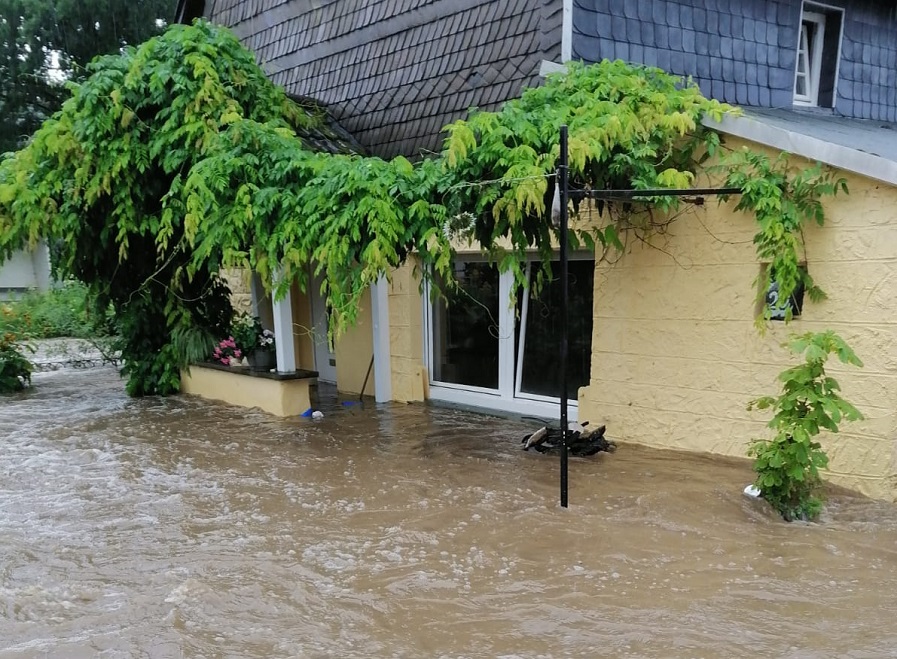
[424,255,595,419]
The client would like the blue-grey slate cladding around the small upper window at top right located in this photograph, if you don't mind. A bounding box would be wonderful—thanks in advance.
[572,0,897,121]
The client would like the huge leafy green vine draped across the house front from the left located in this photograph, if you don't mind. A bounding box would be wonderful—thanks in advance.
[0,21,848,395]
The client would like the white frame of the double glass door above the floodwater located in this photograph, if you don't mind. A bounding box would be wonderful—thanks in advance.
[423,253,595,421]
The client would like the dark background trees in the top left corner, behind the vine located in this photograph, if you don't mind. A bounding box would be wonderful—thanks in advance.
[0,0,177,153]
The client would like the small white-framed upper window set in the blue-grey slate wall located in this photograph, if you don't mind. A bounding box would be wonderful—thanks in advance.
[794,2,844,108]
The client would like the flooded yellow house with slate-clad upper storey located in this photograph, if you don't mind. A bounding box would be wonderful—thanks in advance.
[178,0,897,500]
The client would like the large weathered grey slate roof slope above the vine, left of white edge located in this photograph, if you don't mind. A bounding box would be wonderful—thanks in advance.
[194,0,563,157]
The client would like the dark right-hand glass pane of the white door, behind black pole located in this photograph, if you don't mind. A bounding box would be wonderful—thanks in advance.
[520,261,595,400]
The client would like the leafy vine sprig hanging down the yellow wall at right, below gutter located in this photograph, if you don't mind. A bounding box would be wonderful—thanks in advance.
[719,149,847,329]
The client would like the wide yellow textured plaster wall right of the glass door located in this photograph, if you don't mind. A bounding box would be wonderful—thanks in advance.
[579,143,897,500]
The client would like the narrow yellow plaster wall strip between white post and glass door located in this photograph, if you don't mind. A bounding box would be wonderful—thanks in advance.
[389,260,427,403]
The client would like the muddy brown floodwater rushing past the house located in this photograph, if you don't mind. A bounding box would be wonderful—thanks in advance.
[0,369,897,659]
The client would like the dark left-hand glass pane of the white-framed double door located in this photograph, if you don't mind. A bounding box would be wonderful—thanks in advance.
[433,261,499,389]
